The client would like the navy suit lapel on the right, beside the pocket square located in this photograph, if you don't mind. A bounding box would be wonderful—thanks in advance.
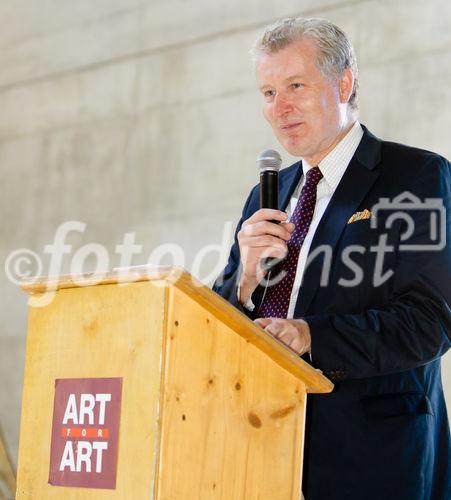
[295,126,380,318]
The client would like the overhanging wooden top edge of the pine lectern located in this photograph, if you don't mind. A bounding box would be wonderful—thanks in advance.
[21,266,334,393]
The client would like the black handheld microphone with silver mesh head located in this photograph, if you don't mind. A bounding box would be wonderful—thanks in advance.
[257,149,282,210]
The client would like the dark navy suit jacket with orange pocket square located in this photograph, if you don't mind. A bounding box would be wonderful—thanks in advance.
[214,128,451,500]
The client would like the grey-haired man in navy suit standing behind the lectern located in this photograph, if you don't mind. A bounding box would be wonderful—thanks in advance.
[214,19,451,500]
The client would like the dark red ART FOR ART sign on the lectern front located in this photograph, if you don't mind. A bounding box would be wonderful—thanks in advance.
[49,378,122,489]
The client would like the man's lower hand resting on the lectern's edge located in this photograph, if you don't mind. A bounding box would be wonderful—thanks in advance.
[254,318,312,355]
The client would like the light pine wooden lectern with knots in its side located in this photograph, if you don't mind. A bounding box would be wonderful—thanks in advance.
[16,268,333,500]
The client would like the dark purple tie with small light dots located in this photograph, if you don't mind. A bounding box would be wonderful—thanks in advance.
[259,167,323,318]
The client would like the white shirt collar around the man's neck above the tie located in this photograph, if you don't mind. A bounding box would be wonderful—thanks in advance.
[302,120,363,191]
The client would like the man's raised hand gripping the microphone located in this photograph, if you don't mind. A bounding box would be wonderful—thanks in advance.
[238,208,294,304]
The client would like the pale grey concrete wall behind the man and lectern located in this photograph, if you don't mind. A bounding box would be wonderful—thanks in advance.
[0,0,451,459]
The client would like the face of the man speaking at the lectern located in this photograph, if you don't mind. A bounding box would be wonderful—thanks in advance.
[256,38,352,164]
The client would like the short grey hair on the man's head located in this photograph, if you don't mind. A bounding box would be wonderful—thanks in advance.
[250,17,359,110]
